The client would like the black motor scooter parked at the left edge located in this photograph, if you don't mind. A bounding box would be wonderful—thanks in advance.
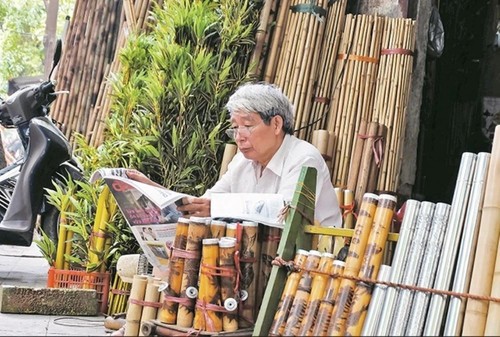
[0,40,83,246]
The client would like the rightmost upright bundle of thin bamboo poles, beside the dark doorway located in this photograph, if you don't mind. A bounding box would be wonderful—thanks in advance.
[372,18,415,192]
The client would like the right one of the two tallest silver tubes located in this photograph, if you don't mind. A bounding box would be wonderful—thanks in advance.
[444,152,491,336]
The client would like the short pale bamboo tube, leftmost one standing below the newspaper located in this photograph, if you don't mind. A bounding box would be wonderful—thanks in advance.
[125,275,148,336]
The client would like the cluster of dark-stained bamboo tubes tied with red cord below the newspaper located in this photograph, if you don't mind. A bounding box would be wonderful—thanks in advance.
[154,217,281,332]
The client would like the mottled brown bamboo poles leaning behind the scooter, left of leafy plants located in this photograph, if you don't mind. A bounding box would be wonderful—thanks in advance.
[52,0,161,145]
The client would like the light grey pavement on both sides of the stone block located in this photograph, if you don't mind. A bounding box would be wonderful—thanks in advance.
[0,240,109,336]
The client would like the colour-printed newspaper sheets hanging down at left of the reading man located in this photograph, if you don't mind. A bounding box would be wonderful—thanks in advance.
[90,168,191,271]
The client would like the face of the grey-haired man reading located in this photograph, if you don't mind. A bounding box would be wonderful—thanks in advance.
[230,112,284,166]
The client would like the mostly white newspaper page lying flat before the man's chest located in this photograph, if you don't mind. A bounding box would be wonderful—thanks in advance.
[210,193,285,228]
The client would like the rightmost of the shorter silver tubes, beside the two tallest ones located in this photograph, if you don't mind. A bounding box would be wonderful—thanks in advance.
[405,202,451,336]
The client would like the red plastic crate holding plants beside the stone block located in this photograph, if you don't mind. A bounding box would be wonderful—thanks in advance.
[47,267,110,313]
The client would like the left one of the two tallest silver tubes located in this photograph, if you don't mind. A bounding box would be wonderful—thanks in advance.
[424,152,477,336]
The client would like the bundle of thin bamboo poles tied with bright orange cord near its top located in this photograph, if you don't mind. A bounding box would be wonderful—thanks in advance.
[327,14,385,187]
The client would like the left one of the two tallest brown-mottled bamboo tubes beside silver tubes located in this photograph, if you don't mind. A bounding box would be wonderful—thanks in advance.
[328,193,379,336]
